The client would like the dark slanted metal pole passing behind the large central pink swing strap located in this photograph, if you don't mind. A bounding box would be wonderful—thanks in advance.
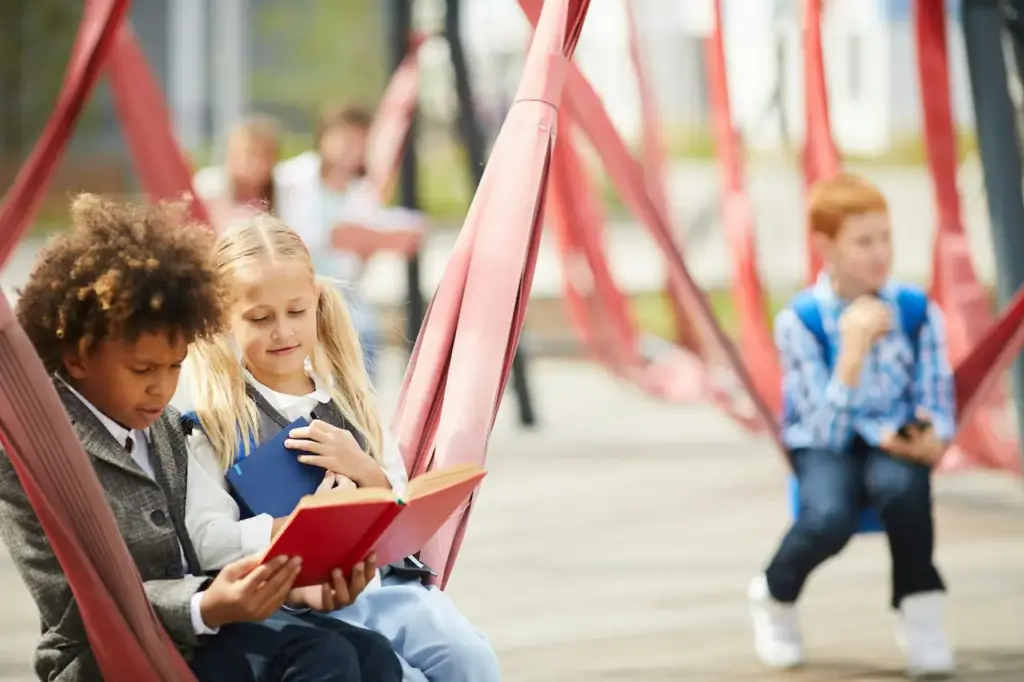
[444,0,537,426]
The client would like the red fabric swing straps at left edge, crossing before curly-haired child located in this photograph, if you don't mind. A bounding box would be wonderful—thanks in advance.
[0,0,194,682]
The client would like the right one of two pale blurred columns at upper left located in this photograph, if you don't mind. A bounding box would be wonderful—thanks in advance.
[210,0,249,156]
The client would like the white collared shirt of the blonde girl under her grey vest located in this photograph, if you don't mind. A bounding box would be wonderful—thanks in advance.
[185,367,409,589]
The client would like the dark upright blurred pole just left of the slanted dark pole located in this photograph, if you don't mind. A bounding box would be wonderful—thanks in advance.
[387,0,426,350]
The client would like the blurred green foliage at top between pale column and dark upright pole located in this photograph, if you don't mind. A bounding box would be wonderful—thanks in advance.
[250,0,387,122]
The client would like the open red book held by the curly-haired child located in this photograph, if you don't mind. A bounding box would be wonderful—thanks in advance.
[260,464,486,587]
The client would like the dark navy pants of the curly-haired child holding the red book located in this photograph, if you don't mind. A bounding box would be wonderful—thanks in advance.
[191,610,401,682]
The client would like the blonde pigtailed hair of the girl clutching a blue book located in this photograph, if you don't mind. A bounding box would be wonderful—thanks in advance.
[188,214,381,471]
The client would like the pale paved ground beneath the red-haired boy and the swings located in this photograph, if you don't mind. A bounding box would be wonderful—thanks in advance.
[0,352,1024,682]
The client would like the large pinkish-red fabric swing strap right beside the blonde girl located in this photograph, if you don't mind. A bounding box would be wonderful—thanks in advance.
[393,0,590,587]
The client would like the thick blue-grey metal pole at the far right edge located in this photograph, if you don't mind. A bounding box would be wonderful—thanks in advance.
[961,0,1024,462]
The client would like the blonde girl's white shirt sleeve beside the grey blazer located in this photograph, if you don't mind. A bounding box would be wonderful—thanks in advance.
[185,429,273,570]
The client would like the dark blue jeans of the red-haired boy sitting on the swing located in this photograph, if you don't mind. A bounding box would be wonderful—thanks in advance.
[765,438,945,608]
